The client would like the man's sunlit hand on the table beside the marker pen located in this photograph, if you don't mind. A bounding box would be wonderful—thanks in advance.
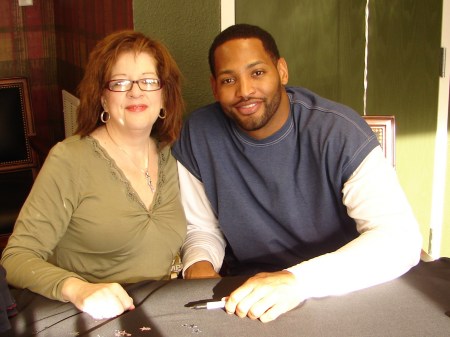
[225,270,304,323]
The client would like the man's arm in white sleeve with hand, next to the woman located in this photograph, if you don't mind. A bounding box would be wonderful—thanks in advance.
[178,162,226,278]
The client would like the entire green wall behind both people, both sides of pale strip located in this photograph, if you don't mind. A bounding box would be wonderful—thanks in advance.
[133,0,450,256]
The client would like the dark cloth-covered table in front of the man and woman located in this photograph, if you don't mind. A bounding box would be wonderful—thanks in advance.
[2,259,450,337]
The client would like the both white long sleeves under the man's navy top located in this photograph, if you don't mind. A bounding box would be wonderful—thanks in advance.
[178,147,422,299]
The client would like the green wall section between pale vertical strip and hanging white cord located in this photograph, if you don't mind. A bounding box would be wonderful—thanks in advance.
[236,0,365,113]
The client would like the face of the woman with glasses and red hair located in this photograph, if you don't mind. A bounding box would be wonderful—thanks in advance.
[102,52,163,131]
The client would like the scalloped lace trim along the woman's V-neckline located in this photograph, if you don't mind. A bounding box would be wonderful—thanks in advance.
[86,136,167,212]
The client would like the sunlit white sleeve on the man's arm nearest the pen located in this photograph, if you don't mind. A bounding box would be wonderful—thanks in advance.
[287,147,422,299]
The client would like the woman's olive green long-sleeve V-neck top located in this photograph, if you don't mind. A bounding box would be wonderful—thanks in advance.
[1,136,186,301]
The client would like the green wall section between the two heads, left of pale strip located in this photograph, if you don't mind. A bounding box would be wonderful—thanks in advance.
[133,0,220,113]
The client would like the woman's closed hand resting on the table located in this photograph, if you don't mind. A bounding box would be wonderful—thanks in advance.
[62,277,134,319]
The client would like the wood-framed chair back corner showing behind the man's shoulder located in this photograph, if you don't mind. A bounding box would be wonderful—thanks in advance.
[363,116,395,167]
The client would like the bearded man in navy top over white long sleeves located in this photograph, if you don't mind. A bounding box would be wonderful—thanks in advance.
[173,24,421,322]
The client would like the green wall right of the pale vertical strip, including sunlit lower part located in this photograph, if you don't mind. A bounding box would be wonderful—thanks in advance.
[236,0,450,256]
